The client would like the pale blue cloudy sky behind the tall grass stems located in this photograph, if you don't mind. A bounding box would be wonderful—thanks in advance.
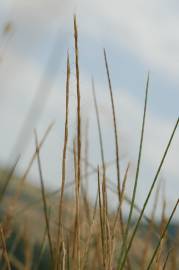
[0,0,179,219]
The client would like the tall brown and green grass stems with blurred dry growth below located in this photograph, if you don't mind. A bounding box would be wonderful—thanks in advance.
[0,17,179,270]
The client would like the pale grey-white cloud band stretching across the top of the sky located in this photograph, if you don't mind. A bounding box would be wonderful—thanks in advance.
[1,0,179,79]
